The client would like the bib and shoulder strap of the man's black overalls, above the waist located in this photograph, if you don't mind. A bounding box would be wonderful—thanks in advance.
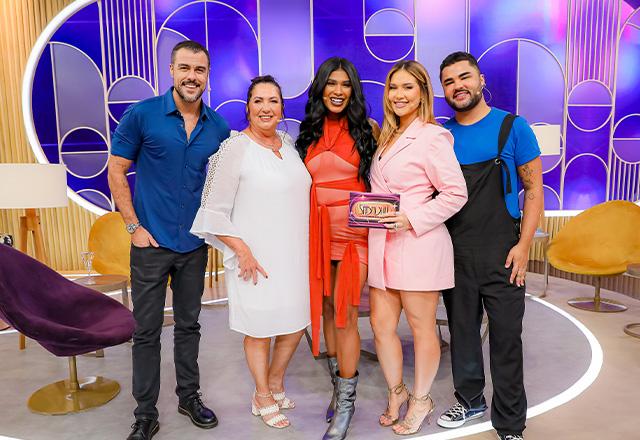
[446,114,519,248]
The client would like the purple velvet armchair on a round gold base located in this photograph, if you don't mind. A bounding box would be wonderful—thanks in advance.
[0,245,135,414]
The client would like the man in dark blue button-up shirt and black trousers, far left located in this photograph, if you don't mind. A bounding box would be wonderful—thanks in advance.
[109,41,229,440]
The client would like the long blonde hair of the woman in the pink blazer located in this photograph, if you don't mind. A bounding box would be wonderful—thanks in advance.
[378,60,440,147]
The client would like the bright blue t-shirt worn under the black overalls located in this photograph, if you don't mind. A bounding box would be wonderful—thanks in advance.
[444,107,540,218]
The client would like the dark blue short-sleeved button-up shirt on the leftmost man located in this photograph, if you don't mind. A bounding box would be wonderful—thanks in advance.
[111,87,229,253]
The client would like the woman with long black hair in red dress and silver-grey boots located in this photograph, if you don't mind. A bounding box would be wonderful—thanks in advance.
[296,57,379,440]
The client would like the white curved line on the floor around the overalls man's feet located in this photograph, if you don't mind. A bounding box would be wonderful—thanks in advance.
[413,294,604,440]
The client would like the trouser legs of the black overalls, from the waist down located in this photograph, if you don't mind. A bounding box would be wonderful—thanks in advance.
[443,242,527,435]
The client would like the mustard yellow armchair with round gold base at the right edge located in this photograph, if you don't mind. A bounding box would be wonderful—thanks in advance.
[548,200,640,312]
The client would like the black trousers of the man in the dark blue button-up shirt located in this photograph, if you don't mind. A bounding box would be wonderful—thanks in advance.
[131,246,207,419]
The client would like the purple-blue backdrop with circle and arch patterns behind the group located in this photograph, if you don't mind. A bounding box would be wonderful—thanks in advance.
[25,0,640,212]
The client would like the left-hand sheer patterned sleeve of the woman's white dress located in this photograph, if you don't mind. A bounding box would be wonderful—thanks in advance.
[191,132,246,251]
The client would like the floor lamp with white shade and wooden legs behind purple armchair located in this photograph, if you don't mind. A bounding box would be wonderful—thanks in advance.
[0,163,69,349]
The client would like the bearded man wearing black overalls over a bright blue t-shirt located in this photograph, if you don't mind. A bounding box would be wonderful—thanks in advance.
[438,52,543,440]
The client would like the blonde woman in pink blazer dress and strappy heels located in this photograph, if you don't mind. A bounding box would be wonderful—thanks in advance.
[368,61,467,435]
